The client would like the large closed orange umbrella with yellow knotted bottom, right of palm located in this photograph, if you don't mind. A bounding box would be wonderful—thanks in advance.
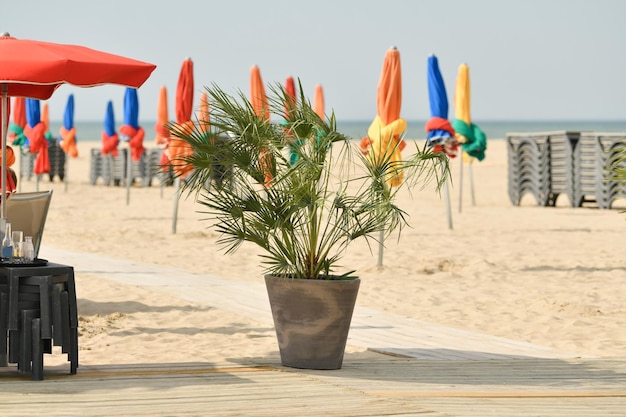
[360,47,406,187]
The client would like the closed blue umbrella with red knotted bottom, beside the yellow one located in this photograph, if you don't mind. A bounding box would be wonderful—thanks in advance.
[425,55,458,229]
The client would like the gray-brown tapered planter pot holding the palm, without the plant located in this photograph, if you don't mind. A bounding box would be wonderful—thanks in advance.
[265,275,361,369]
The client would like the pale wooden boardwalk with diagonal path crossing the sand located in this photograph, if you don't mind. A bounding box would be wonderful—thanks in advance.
[0,248,626,417]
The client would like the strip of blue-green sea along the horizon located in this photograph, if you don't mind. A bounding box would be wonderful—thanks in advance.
[40,118,626,144]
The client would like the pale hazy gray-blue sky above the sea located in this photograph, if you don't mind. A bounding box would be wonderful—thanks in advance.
[0,0,626,123]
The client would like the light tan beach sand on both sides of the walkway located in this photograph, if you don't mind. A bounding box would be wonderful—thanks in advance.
[17,140,626,364]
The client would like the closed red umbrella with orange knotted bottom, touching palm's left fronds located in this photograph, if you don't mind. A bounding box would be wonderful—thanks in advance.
[168,58,194,178]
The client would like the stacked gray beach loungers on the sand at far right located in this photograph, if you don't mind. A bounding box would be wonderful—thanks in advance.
[507,131,626,208]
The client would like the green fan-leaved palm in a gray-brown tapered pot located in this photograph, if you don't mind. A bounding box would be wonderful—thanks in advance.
[170,79,447,369]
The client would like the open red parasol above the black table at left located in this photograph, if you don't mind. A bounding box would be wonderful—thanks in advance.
[0,33,156,219]
